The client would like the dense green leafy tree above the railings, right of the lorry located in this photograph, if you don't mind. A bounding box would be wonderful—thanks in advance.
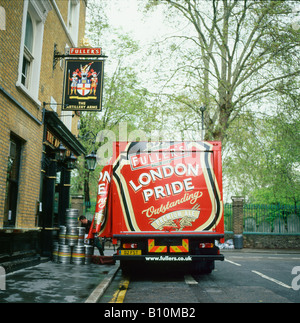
[224,107,300,205]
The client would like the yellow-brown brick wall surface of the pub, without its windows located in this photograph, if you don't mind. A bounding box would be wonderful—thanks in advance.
[0,0,86,233]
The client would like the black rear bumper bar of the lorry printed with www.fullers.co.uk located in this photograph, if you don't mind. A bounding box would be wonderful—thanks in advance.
[114,255,224,262]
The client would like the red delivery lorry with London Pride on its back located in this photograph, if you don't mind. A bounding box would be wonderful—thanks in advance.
[93,141,224,273]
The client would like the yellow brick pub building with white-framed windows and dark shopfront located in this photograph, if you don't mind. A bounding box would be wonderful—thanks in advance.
[0,0,87,263]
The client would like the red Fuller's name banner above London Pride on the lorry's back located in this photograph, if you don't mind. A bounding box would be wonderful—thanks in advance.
[129,143,190,170]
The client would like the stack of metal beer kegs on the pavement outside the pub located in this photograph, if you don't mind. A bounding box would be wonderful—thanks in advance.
[52,209,93,265]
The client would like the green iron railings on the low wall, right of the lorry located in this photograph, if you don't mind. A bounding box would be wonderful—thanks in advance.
[224,204,300,234]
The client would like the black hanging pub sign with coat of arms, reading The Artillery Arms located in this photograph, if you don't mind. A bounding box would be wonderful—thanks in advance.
[62,59,104,111]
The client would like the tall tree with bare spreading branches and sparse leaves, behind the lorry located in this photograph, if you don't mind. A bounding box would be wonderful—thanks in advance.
[146,0,300,140]
